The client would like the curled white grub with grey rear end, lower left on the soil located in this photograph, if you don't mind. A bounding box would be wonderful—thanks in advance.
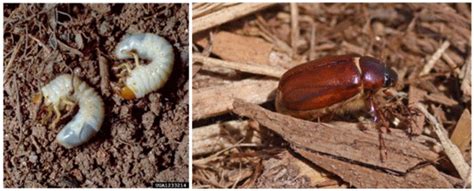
[41,74,104,149]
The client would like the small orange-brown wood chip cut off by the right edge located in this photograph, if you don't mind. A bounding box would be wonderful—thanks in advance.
[451,109,471,151]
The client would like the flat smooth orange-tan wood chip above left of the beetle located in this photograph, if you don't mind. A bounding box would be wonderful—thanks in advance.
[196,31,273,64]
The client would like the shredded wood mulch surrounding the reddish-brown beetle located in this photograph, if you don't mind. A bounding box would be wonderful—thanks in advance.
[192,3,472,188]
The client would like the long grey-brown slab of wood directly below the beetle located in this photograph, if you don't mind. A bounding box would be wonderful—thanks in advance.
[233,100,438,173]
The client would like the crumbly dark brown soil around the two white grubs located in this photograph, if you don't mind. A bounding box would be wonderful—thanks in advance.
[3,4,189,187]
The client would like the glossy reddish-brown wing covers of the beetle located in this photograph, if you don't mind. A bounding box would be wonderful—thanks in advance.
[278,56,362,110]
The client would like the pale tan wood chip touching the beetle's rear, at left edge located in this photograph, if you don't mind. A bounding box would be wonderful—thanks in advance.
[193,79,278,120]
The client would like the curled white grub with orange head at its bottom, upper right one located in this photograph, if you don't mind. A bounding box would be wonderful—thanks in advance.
[115,33,174,100]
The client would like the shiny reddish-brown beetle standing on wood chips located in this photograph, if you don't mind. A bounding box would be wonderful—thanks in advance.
[275,55,398,122]
